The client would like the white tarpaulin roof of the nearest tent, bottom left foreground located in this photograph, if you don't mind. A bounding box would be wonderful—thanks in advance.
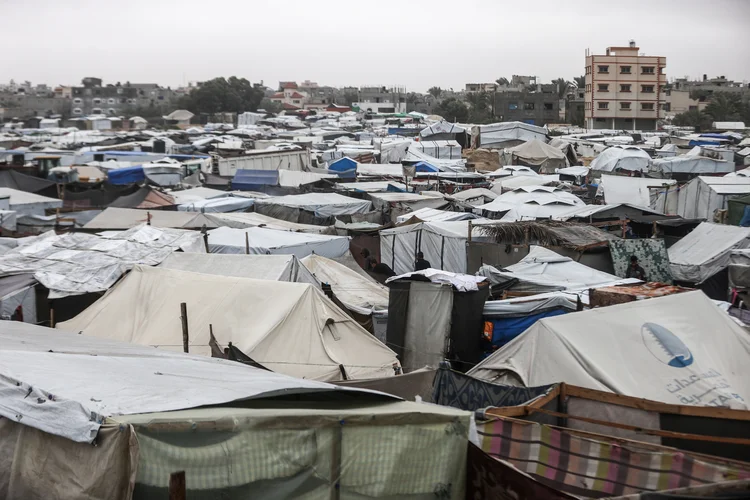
[0,320,386,443]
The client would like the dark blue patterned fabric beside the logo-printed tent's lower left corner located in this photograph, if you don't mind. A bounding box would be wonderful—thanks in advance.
[432,367,552,411]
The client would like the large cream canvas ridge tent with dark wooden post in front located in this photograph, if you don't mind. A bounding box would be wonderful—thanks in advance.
[59,266,398,380]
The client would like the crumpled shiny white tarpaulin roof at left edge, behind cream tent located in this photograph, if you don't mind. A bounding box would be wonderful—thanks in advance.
[0,225,203,299]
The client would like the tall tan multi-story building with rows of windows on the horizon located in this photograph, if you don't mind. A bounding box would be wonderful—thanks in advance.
[585,41,667,130]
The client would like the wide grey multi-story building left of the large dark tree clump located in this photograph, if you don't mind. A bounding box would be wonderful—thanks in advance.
[70,77,174,117]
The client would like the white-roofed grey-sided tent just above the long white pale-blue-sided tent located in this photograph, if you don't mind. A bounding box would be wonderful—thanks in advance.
[255,193,372,222]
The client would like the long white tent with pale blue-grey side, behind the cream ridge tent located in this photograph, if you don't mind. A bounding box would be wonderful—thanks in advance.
[208,227,349,259]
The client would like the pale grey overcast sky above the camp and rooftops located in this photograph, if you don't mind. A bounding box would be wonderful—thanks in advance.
[0,0,750,91]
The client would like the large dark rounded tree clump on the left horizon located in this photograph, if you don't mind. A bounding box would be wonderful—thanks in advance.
[181,76,264,114]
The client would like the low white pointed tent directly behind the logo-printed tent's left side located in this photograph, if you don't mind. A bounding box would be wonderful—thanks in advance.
[477,245,640,292]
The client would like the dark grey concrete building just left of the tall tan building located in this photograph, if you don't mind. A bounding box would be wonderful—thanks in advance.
[494,85,560,125]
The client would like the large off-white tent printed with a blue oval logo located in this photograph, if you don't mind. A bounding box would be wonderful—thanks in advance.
[469,291,750,409]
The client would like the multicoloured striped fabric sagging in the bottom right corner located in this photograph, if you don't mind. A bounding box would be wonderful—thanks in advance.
[477,418,750,498]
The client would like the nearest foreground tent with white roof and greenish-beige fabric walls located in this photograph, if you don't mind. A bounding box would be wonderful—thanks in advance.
[0,322,470,500]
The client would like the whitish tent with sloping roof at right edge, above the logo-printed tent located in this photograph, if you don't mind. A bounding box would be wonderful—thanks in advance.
[667,222,750,284]
